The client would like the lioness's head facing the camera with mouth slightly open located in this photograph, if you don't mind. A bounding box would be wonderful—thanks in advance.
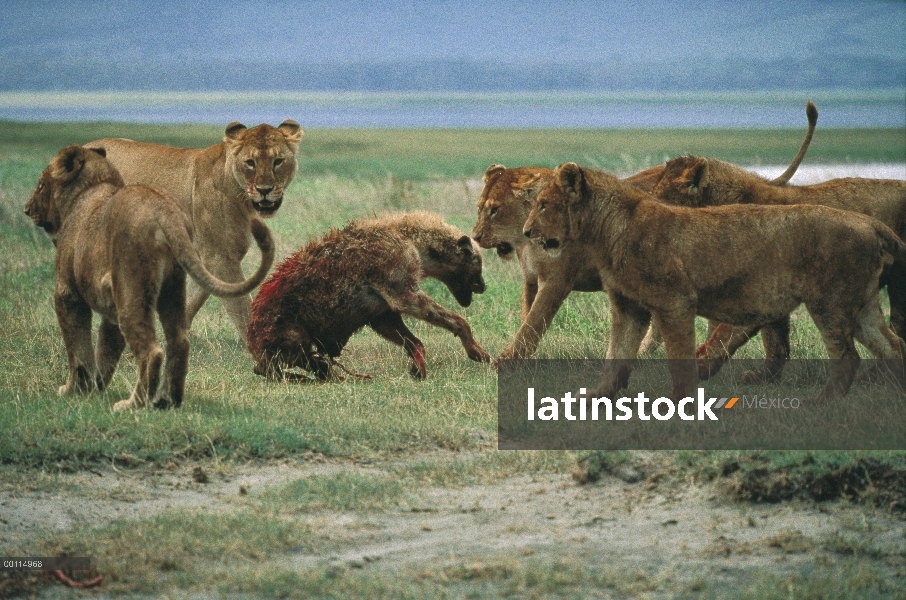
[223,119,302,217]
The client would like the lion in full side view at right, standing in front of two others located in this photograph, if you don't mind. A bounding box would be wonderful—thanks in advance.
[524,163,906,399]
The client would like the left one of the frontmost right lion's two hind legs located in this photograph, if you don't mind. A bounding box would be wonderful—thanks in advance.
[806,308,860,400]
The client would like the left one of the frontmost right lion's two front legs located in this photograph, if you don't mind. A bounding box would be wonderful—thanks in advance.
[594,292,651,398]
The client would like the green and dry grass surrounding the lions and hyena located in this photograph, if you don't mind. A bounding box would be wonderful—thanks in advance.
[0,123,906,598]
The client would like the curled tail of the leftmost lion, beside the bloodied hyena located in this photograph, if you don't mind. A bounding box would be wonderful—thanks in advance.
[167,217,276,298]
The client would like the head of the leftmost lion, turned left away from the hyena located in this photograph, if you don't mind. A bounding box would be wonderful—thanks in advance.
[25,144,123,238]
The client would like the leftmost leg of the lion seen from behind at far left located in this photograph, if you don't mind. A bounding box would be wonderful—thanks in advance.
[54,290,101,396]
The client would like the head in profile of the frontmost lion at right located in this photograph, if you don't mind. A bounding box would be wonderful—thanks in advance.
[523,163,583,256]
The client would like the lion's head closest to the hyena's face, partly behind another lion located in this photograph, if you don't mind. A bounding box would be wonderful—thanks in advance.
[472,165,553,258]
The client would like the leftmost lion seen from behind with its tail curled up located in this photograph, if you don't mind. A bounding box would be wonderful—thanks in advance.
[25,145,274,410]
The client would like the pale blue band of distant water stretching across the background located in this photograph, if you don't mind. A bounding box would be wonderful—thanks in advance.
[0,90,906,128]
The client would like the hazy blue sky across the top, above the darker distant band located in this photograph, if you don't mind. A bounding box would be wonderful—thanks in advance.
[0,0,906,89]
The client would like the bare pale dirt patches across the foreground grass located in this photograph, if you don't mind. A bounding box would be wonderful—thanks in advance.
[0,462,906,585]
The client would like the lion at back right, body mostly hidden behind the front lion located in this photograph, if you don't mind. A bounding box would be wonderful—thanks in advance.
[652,121,906,381]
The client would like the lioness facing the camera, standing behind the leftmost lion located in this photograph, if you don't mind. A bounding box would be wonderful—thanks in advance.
[85,119,302,339]
